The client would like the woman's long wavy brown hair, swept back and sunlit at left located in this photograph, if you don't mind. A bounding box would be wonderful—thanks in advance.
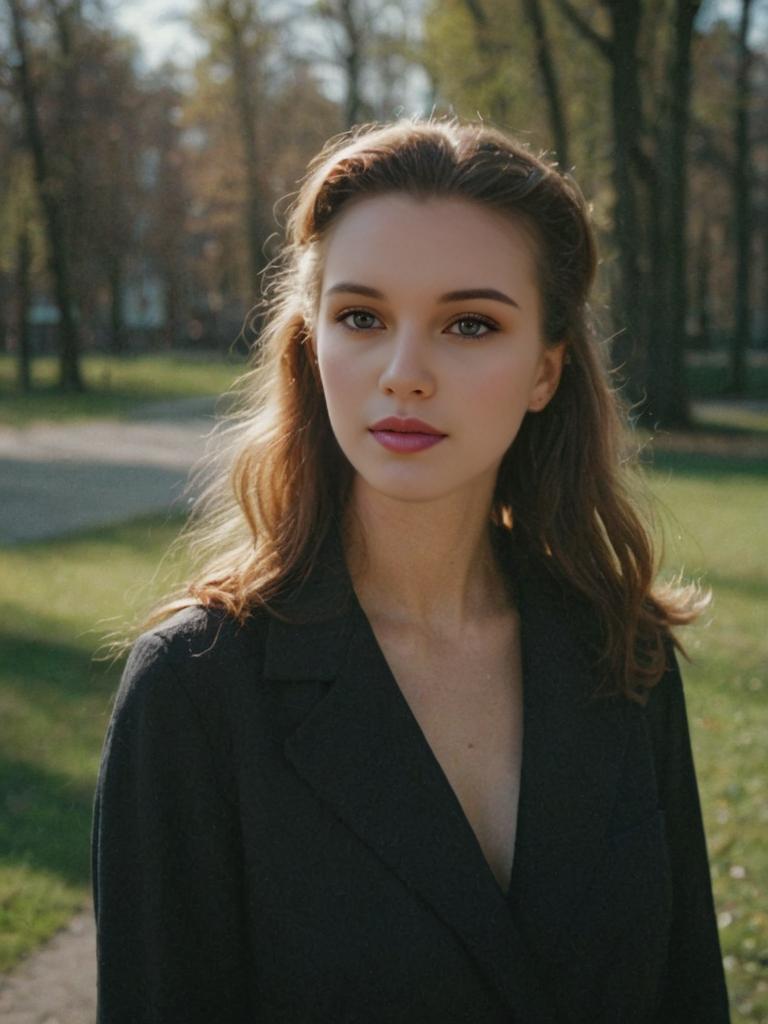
[143,118,706,702]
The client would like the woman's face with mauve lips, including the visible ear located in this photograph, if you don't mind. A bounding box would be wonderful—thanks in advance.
[314,194,563,501]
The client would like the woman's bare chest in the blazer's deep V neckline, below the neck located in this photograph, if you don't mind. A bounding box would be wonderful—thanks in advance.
[366,614,523,893]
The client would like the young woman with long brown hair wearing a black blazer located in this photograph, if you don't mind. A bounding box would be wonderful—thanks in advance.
[93,121,728,1024]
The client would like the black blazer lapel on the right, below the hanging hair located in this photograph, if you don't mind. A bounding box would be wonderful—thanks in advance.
[509,540,629,961]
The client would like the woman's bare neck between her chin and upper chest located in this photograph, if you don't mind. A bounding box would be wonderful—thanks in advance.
[344,477,510,638]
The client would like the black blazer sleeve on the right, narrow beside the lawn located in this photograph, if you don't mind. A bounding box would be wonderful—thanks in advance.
[649,644,730,1024]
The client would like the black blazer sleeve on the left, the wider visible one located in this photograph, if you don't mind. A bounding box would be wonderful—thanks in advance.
[91,634,252,1024]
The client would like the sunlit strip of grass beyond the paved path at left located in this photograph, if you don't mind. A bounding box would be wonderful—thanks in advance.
[0,355,245,426]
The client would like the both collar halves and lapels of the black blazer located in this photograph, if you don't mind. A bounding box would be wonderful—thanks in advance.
[265,527,627,1024]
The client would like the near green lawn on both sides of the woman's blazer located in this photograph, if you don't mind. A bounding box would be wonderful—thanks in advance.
[0,460,768,1024]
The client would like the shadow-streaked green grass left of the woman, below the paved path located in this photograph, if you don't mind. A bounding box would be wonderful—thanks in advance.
[0,520,191,971]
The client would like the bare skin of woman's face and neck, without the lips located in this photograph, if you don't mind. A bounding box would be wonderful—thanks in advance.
[313,195,564,637]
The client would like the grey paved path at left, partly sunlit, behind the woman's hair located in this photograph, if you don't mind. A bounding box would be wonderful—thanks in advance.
[0,399,222,545]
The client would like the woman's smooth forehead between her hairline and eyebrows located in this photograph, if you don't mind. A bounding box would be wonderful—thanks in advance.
[323,194,536,291]
